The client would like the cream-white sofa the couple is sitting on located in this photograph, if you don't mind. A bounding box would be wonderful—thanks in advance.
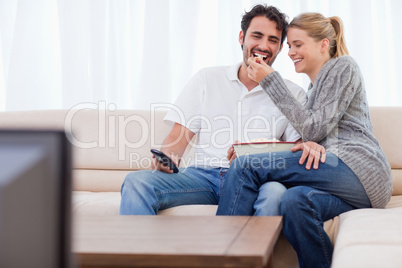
[0,105,402,268]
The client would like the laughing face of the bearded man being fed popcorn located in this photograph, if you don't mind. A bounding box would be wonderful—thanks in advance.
[239,16,282,66]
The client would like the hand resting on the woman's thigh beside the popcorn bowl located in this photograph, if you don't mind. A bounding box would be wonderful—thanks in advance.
[291,141,327,170]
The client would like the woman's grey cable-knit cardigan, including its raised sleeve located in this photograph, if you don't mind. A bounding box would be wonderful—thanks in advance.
[261,56,392,208]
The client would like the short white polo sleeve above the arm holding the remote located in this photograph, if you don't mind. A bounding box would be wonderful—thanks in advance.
[164,70,205,133]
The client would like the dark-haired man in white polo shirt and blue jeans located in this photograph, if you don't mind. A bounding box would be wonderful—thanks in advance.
[120,5,306,215]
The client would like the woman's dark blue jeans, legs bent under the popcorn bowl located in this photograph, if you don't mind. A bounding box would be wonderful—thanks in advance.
[217,152,371,267]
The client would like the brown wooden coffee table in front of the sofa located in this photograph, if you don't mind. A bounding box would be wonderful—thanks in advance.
[73,216,282,267]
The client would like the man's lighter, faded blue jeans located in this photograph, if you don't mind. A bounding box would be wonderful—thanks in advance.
[120,167,286,215]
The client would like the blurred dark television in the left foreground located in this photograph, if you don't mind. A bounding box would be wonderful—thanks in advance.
[0,130,72,268]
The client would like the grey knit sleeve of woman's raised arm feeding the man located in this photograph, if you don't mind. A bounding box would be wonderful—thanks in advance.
[261,58,360,142]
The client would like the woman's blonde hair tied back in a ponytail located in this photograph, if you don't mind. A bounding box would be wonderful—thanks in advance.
[289,13,349,58]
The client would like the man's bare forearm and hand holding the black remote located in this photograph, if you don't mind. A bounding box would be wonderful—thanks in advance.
[152,123,195,173]
